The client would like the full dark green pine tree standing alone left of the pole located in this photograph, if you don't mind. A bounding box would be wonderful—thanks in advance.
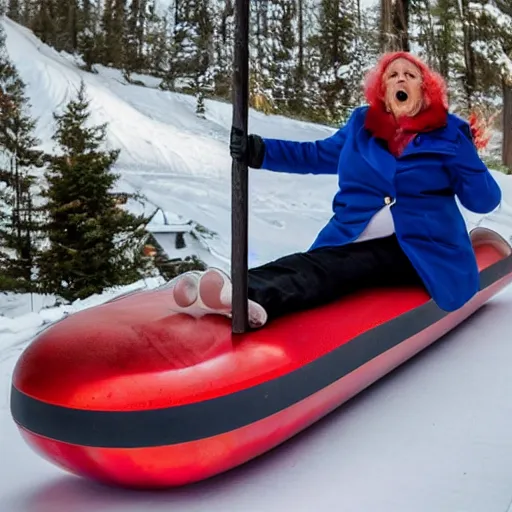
[40,83,151,300]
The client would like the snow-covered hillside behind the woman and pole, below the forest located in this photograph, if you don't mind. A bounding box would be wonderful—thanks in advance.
[0,15,512,332]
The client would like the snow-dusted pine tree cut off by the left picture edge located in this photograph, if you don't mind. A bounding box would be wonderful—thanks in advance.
[0,27,43,292]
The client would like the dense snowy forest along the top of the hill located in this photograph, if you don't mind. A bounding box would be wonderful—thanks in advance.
[4,0,512,169]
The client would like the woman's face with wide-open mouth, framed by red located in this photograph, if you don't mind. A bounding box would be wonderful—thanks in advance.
[383,58,423,117]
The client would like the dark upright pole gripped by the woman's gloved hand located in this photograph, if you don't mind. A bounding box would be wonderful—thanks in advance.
[231,0,249,334]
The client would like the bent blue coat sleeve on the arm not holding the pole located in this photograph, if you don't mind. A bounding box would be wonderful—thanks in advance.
[448,125,501,214]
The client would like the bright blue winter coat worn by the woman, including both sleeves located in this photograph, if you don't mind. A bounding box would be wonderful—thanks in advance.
[262,106,501,311]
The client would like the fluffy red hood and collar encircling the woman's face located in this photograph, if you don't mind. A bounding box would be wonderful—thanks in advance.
[364,52,448,154]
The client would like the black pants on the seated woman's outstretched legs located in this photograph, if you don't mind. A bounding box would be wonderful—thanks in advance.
[248,236,423,320]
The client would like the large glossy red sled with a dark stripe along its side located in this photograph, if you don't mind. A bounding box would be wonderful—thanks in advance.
[7,228,512,488]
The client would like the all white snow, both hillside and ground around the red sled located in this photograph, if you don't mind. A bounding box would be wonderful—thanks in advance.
[0,16,512,512]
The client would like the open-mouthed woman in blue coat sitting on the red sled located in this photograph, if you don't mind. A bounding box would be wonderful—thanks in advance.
[169,52,501,328]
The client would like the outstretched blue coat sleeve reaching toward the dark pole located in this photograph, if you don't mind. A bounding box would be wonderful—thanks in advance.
[261,110,352,174]
